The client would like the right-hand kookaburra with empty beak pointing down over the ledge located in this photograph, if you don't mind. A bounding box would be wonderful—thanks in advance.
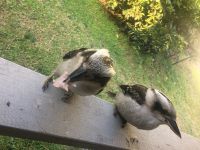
[108,84,181,138]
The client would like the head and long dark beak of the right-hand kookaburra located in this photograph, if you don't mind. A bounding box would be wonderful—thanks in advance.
[146,88,181,138]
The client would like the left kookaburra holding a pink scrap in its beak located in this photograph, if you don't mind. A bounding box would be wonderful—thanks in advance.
[42,48,115,99]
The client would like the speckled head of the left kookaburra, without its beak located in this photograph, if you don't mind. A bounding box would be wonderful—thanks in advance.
[88,49,115,77]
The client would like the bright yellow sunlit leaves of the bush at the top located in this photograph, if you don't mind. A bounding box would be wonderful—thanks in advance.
[108,0,162,31]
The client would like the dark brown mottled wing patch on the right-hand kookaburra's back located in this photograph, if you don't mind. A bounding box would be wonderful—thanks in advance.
[120,84,147,105]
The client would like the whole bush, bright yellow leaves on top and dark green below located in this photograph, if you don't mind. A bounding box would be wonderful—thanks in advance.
[107,0,186,54]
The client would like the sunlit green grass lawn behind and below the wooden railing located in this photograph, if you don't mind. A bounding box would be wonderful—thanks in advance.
[0,0,200,150]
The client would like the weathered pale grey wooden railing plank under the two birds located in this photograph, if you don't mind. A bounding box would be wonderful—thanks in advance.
[0,58,200,150]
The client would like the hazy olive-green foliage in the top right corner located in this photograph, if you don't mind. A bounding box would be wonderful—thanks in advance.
[161,0,200,34]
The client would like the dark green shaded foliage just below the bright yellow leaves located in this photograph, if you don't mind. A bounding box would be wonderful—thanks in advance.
[128,24,186,54]
